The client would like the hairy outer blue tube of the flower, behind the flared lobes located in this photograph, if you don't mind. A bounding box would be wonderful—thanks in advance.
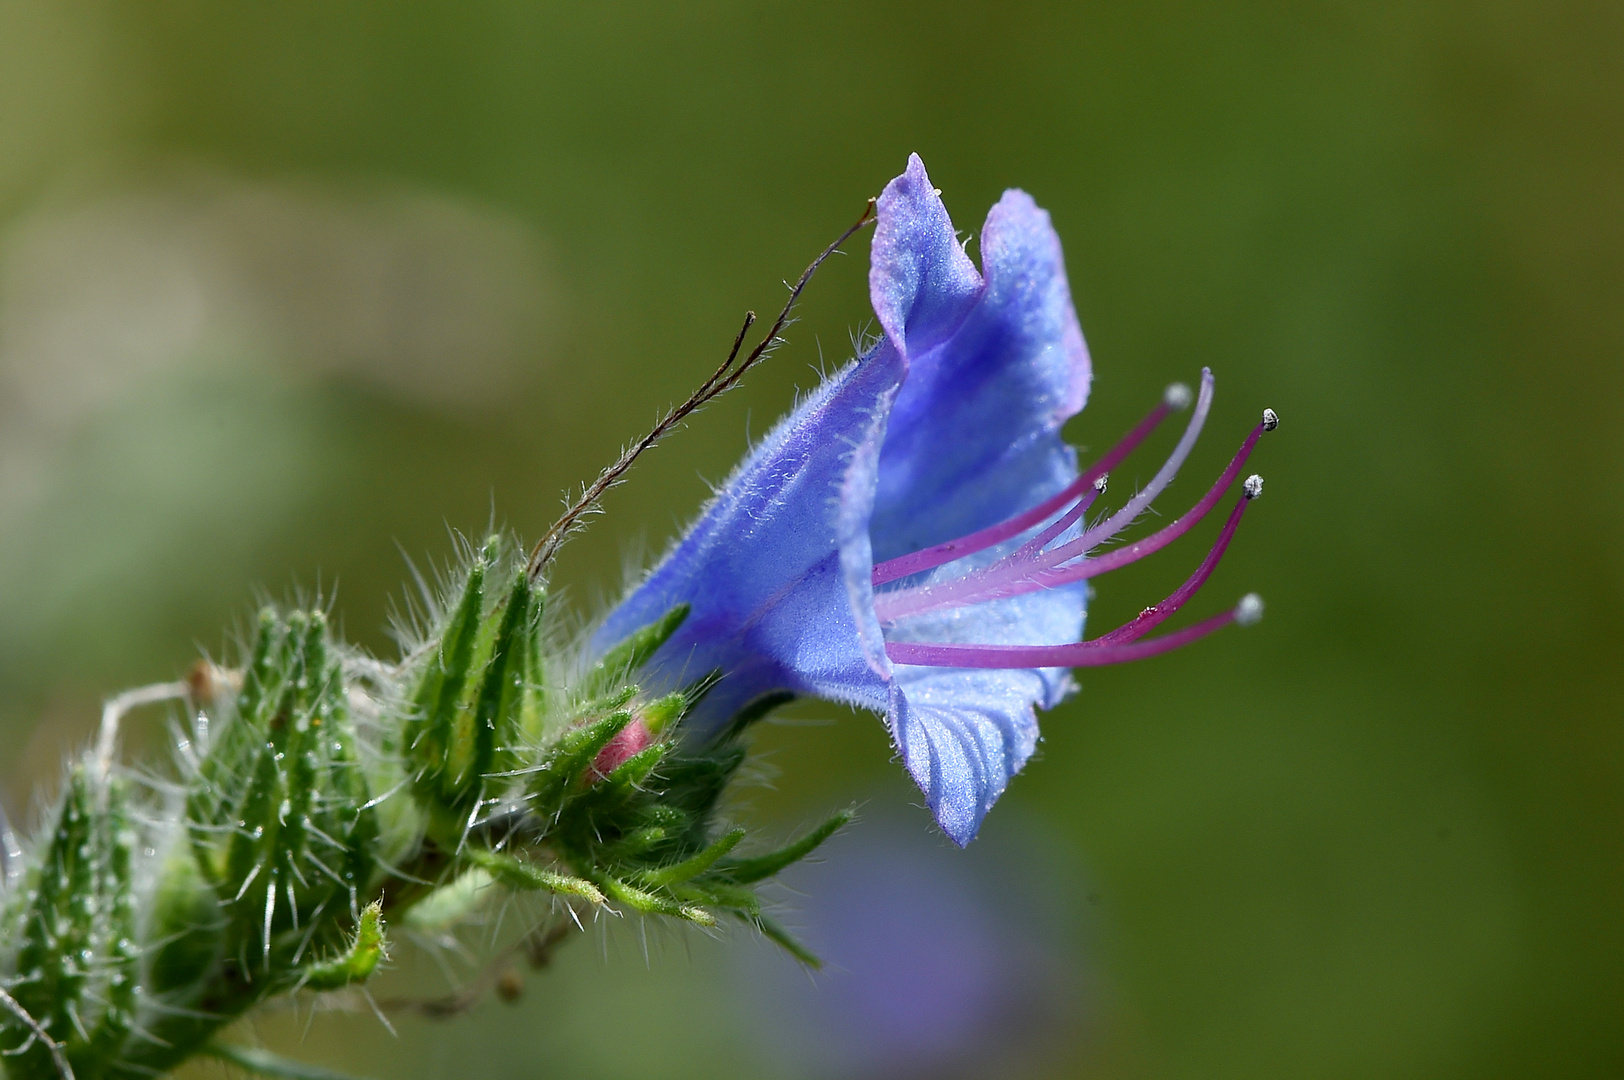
[588,349,903,737]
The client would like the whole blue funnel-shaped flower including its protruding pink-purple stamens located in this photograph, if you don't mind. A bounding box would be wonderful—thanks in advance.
[590,156,1276,845]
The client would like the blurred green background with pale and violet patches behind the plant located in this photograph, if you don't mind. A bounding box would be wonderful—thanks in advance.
[0,0,1624,1080]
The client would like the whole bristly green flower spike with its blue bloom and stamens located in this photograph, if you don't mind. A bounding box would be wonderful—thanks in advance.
[0,158,1280,1080]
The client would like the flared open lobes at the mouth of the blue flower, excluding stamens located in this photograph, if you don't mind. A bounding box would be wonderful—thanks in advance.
[840,158,1090,845]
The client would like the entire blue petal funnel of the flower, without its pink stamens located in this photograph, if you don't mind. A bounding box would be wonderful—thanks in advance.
[590,156,1090,845]
